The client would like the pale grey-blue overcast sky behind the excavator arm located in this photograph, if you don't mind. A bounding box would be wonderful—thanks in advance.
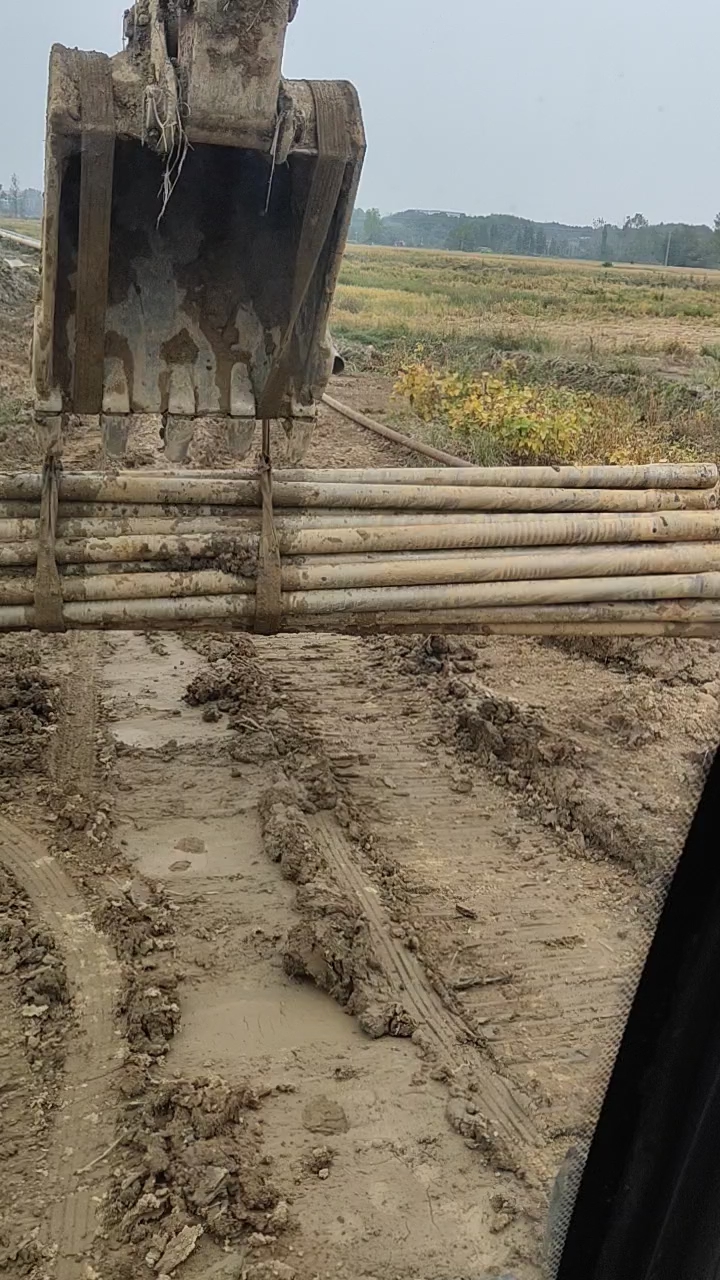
[0,0,720,223]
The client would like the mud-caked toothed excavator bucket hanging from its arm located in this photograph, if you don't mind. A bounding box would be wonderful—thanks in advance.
[33,0,365,461]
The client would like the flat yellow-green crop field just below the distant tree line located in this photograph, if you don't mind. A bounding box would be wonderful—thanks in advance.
[334,246,720,361]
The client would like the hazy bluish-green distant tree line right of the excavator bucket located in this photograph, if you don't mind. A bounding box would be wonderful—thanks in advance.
[350,209,720,268]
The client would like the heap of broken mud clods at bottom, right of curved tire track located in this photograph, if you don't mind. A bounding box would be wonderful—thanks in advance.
[111,1078,288,1275]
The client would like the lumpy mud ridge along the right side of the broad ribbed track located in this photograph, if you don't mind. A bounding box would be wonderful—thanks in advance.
[379,636,675,876]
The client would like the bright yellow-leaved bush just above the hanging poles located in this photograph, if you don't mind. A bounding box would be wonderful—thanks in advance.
[396,360,697,466]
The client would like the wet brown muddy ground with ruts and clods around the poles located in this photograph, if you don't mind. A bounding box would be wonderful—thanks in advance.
[0,272,720,1280]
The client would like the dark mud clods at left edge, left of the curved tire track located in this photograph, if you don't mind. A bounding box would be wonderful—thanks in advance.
[0,869,69,1082]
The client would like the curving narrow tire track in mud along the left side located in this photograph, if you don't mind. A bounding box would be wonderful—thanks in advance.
[0,634,123,1280]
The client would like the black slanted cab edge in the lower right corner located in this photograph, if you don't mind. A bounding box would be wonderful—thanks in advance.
[550,755,720,1280]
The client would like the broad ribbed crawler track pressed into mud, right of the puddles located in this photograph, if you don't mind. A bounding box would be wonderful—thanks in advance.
[258,637,638,1178]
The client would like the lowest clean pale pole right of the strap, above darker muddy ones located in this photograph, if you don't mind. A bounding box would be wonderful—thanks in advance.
[283,573,720,616]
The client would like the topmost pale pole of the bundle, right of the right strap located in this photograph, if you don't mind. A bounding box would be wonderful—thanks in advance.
[271,462,719,489]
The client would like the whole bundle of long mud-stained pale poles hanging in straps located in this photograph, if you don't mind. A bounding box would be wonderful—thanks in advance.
[0,465,720,635]
